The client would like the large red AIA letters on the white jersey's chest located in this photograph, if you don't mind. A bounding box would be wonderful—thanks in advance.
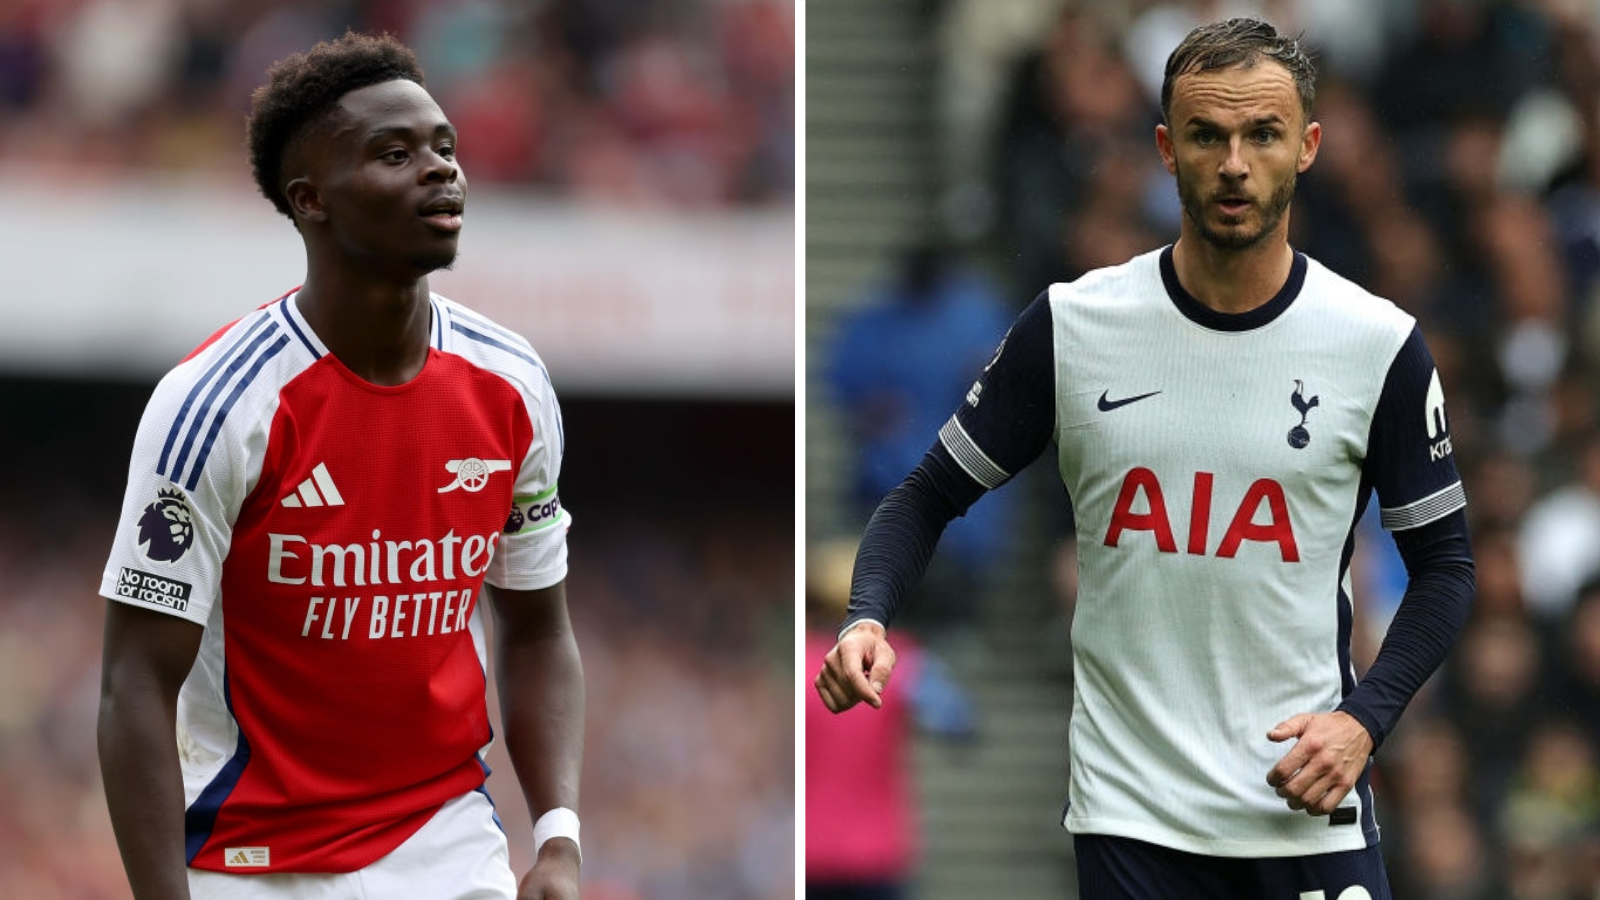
[1106,466,1299,562]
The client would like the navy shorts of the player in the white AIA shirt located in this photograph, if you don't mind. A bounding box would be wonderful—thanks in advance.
[1074,834,1392,900]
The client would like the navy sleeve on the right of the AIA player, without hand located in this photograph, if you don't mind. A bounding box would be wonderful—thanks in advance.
[1339,330,1474,746]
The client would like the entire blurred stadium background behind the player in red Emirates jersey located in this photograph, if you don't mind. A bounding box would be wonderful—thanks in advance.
[0,0,795,900]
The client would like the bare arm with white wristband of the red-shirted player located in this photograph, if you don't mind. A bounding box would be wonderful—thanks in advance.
[490,580,584,900]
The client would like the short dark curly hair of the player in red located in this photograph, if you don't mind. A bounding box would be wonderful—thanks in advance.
[245,32,424,221]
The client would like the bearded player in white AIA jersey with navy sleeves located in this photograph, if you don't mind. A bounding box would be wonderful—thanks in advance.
[818,19,1472,900]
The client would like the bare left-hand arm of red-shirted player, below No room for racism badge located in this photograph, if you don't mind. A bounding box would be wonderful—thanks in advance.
[96,601,203,900]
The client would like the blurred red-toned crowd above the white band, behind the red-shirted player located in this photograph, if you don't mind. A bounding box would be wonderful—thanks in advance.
[0,0,795,208]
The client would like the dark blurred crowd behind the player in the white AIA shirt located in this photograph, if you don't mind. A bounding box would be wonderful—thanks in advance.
[835,0,1600,900]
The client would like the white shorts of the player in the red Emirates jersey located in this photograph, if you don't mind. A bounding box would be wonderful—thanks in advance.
[189,791,517,900]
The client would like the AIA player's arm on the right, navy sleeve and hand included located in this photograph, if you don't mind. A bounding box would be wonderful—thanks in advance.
[1267,323,1474,815]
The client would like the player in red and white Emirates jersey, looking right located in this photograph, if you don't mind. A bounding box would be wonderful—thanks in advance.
[99,34,584,900]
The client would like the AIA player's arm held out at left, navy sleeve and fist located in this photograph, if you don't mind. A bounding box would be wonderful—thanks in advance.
[814,295,1054,713]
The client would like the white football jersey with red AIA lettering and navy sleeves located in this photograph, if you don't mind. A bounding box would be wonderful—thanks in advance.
[941,248,1466,857]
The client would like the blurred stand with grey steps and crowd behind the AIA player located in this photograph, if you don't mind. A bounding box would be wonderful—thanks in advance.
[805,0,1600,900]
